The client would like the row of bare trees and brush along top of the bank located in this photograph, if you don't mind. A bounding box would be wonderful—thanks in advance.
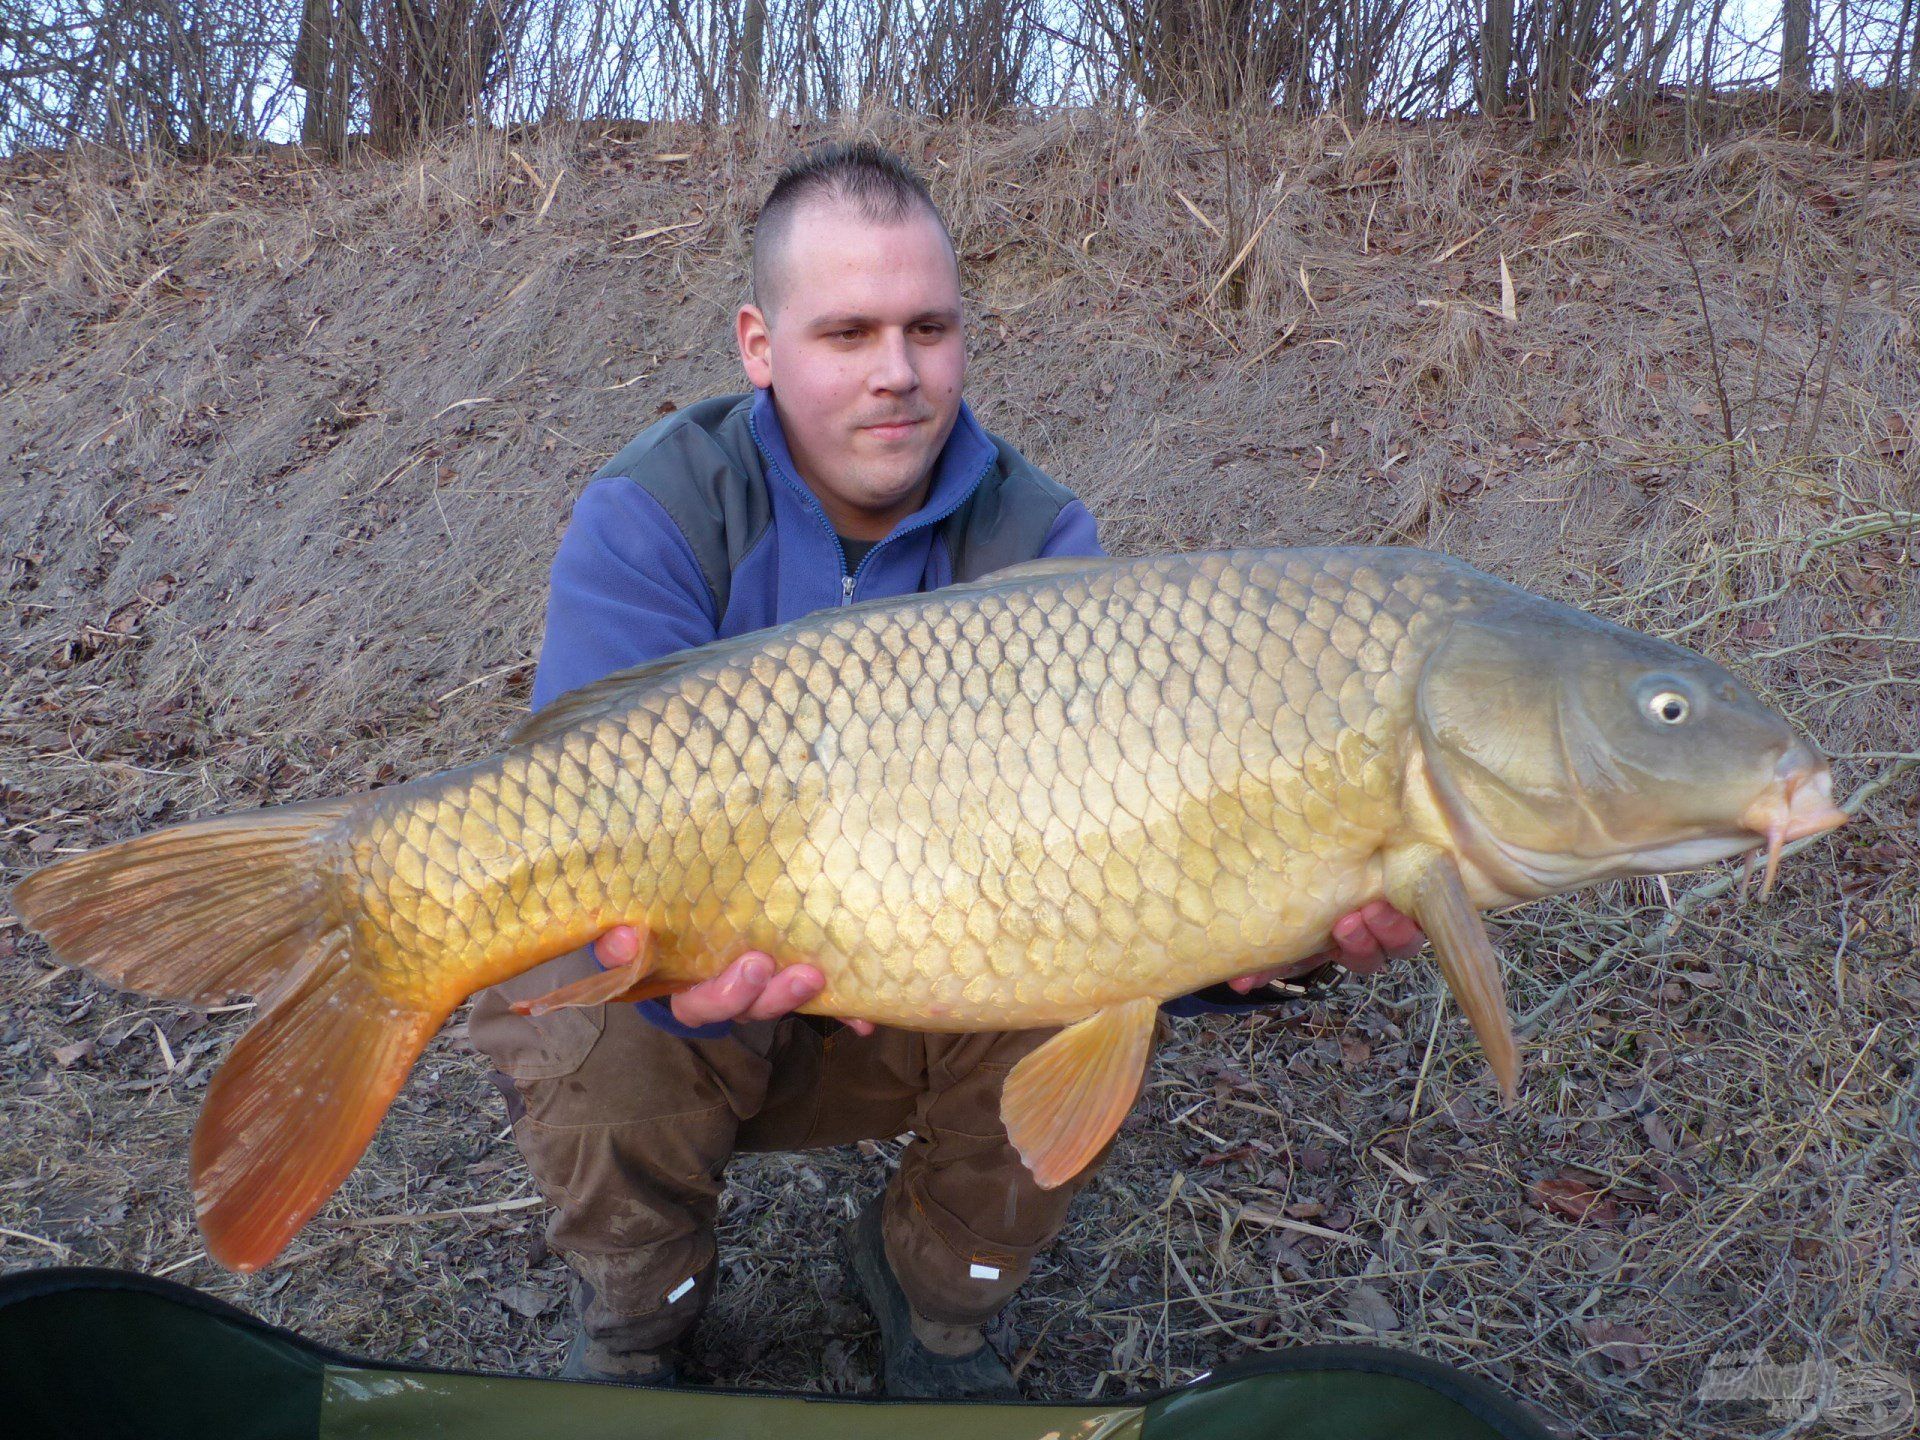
[0,0,1920,154]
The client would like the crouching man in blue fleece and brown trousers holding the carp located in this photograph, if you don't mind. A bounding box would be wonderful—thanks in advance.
[472,146,1419,1396]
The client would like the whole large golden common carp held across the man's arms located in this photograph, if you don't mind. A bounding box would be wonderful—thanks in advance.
[13,549,1845,1269]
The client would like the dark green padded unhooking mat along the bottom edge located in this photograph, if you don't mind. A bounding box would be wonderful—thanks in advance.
[0,1269,1549,1440]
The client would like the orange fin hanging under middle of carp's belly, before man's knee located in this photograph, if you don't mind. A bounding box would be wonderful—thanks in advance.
[1000,998,1160,1190]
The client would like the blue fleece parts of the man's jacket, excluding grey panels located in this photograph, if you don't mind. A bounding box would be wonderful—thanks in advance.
[534,390,1282,1039]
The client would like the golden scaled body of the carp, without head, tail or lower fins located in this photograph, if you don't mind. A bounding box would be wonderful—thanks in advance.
[334,551,1475,1029]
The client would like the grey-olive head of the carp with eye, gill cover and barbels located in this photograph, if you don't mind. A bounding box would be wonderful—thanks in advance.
[1417,597,1847,899]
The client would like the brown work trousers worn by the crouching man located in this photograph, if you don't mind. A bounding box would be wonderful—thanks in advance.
[468,950,1104,1356]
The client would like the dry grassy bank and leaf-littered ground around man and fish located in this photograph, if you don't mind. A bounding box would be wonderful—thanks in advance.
[0,115,1920,1436]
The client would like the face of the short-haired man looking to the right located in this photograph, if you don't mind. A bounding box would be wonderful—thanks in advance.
[737,200,966,540]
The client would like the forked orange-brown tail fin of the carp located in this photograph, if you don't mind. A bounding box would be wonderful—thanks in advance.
[13,801,445,1271]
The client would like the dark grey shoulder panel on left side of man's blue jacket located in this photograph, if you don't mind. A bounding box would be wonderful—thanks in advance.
[593,394,774,614]
